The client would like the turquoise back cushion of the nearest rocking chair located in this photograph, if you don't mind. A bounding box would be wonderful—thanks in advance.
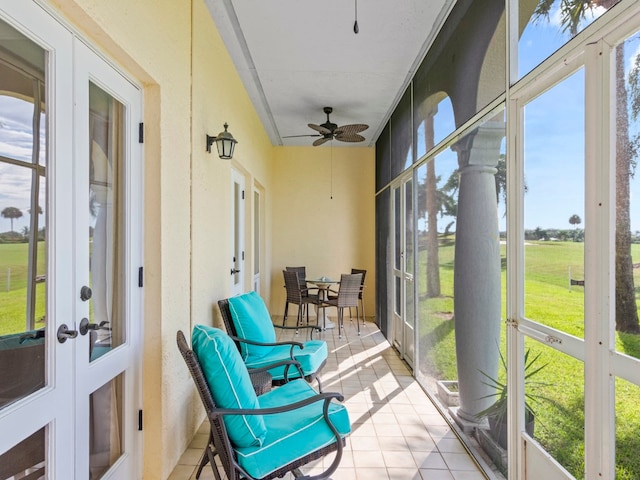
[191,325,267,447]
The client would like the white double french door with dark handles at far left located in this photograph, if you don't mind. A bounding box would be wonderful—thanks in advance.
[0,1,142,479]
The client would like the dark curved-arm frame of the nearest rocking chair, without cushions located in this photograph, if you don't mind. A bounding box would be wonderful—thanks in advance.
[176,330,346,480]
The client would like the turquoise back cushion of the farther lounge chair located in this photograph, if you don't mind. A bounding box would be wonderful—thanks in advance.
[229,292,276,360]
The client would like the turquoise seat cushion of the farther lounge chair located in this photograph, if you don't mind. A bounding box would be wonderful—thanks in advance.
[245,340,328,380]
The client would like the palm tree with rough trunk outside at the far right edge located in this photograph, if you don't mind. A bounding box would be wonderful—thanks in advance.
[533,0,640,333]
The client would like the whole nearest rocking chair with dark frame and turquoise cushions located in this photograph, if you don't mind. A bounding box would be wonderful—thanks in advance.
[177,325,351,480]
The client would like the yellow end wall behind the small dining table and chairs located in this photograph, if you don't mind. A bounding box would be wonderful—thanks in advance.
[270,142,375,316]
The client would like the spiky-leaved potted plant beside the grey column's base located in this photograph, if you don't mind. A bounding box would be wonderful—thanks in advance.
[476,349,549,449]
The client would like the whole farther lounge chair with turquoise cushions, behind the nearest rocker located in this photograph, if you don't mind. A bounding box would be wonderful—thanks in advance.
[218,292,328,390]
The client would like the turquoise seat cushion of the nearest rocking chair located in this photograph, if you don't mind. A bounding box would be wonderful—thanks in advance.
[236,379,351,478]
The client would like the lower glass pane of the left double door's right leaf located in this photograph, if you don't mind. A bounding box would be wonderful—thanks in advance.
[89,374,123,480]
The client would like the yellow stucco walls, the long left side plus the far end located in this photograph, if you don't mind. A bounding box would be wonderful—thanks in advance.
[38,0,375,480]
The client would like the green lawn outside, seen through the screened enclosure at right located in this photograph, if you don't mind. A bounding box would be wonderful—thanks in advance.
[418,239,640,480]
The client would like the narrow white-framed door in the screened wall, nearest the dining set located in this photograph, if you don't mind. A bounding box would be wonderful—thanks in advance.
[391,175,415,366]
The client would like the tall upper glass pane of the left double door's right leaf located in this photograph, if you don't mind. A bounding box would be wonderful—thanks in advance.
[89,83,125,361]
